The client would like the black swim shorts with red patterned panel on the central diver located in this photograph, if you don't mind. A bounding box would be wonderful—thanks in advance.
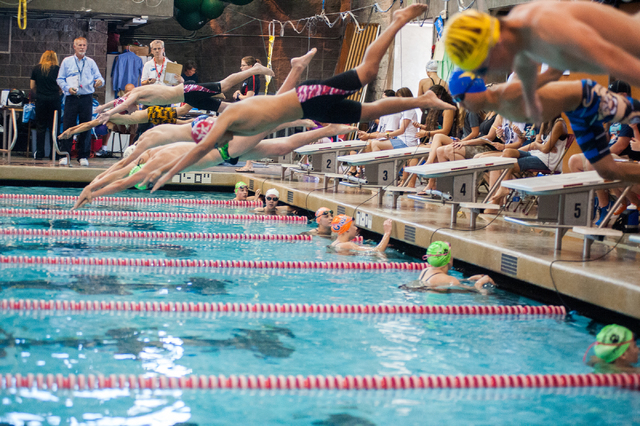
[296,69,362,124]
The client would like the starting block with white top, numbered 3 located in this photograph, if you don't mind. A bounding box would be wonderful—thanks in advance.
[338,146,431,205]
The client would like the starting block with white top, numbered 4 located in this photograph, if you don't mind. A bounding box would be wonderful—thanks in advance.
[405,157,518,229]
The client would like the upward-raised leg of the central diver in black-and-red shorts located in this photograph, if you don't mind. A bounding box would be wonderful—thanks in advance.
[356,4,428,86]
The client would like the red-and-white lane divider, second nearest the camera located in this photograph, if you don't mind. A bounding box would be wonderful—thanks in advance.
[0,299,567,316]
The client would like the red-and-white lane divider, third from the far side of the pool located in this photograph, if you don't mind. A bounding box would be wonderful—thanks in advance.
[0,229,313,241]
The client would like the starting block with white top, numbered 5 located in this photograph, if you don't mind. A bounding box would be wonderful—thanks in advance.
[502,171,631,258]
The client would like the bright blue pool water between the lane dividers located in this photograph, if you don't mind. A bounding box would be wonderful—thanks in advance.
[0,187,640,425]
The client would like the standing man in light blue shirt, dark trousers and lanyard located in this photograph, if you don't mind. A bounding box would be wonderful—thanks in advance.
[56,37,104,167]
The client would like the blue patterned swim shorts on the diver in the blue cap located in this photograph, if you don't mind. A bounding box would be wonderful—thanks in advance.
[566,80,640,164]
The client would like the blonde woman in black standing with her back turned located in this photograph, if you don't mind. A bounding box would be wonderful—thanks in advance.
[31,50,60,160]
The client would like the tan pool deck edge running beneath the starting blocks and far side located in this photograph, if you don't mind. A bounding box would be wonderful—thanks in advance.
[0,156,640,319]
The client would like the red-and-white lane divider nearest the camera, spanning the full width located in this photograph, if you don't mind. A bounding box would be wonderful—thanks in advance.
[0,373,640,390]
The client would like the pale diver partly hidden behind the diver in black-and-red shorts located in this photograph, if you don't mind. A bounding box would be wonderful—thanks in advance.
[72,124,357,210]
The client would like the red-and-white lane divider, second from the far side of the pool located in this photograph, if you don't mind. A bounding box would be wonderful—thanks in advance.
[0,208,308,223]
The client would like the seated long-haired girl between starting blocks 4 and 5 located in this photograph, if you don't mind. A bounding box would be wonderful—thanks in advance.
[485,117,569,213]
